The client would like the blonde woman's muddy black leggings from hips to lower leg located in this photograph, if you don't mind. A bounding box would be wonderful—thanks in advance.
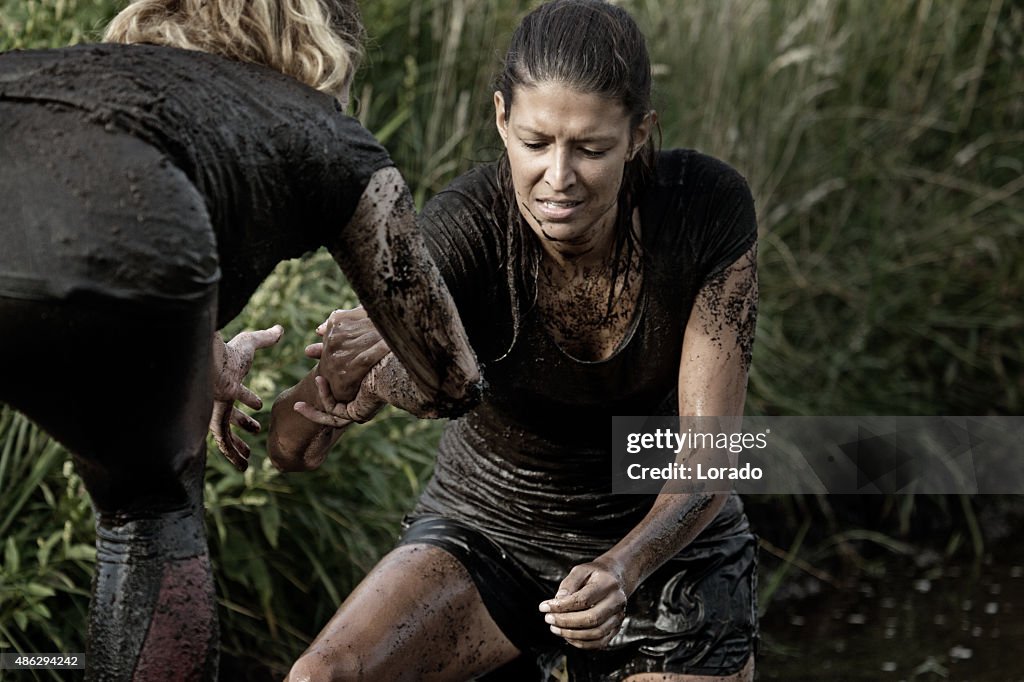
[0,101,224,681]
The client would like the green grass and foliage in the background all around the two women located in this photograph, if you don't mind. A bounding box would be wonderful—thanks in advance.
[0,0,1024,679]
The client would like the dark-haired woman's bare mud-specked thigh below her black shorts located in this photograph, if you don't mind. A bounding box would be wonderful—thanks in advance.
[289,545,519,682]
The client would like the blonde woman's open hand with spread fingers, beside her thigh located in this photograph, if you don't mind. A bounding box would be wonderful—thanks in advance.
[210,325,285,471]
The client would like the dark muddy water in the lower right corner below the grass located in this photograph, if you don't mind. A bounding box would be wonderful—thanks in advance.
[758,539,1024,682]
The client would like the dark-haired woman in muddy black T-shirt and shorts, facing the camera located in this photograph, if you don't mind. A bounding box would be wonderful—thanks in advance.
[270,0,758,682]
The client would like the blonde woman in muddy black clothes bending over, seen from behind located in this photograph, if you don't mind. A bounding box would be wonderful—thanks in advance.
[0,0,478,680]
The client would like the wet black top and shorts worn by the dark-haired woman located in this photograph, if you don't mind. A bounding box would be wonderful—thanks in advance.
[403,150,757,680]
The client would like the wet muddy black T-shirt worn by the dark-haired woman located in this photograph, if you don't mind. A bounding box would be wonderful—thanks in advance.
[417,150,757,580]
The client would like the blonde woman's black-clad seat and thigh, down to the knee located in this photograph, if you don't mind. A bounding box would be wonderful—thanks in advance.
[0,101,219,511]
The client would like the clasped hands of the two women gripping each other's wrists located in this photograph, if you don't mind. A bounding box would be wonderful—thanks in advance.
[295,306,391,428]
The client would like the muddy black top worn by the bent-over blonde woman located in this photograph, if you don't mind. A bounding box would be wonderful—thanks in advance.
[0,44,392,326]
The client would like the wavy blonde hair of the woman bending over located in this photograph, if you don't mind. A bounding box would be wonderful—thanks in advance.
[103,0,364,96]
